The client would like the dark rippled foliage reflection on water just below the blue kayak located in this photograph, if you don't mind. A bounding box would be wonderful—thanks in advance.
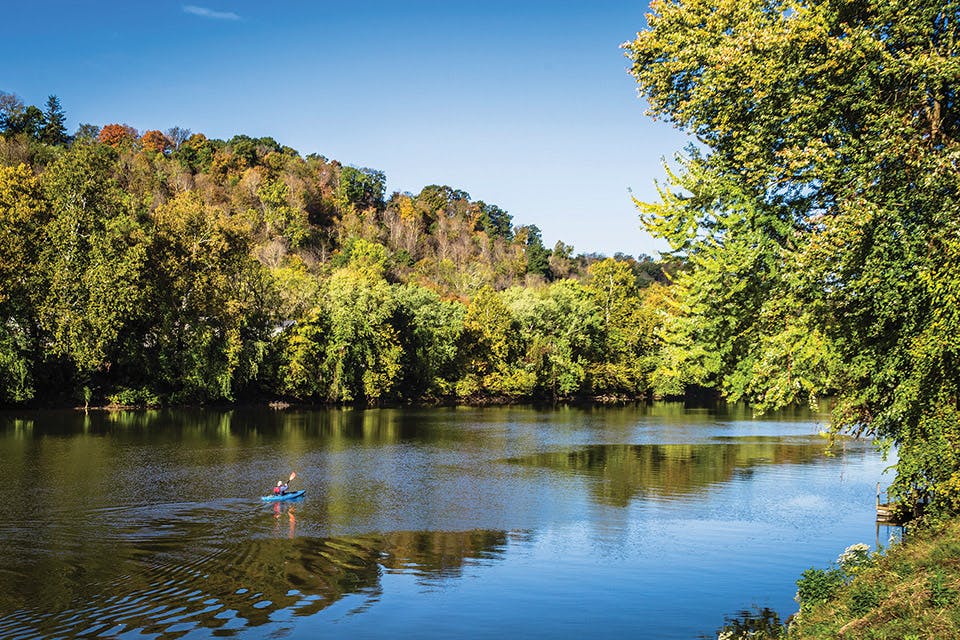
[0,524,510,638]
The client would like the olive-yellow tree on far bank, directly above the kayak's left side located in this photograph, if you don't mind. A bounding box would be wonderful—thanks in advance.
[144,191,277,401]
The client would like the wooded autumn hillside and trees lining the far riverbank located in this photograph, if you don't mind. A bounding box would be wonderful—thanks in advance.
[0,93,669,405]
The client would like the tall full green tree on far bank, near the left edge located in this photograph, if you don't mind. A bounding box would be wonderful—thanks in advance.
[39,144,149,396]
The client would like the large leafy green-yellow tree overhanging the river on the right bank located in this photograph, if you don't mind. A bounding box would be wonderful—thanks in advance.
[626,0,960,509]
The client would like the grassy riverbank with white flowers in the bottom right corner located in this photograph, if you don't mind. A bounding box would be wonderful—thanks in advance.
[787,519,960,640]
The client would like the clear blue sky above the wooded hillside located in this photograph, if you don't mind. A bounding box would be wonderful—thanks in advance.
[0,0,685,255]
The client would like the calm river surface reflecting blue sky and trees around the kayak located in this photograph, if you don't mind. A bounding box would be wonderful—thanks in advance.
[0,404,889,638]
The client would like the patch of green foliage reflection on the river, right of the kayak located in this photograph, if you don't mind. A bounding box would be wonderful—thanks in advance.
[510,436,844,507]
